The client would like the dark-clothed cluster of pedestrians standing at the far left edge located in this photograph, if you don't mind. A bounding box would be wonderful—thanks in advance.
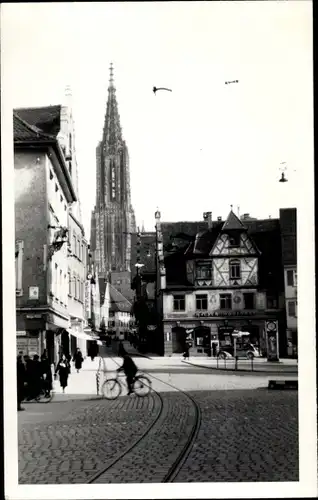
[17,350,52,411]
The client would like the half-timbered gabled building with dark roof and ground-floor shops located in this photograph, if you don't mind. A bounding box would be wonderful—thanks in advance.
[161,210,286,355]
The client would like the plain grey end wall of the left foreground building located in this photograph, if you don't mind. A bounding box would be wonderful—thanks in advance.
[14,151,48,307]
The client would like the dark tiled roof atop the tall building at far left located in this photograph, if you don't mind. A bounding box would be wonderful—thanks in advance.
[14,105,61,137]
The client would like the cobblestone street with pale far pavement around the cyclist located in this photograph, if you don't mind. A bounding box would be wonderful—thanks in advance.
[18,358,298,484]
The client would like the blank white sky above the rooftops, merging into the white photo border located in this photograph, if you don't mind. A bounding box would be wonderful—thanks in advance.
[1,0,313,236]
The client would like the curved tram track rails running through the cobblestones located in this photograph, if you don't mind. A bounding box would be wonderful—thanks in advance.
[87,356,201,484]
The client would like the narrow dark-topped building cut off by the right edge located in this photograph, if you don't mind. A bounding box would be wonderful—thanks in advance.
[279,208,298,355]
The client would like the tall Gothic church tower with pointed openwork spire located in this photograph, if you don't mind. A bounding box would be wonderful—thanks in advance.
[91,64,135,296]
